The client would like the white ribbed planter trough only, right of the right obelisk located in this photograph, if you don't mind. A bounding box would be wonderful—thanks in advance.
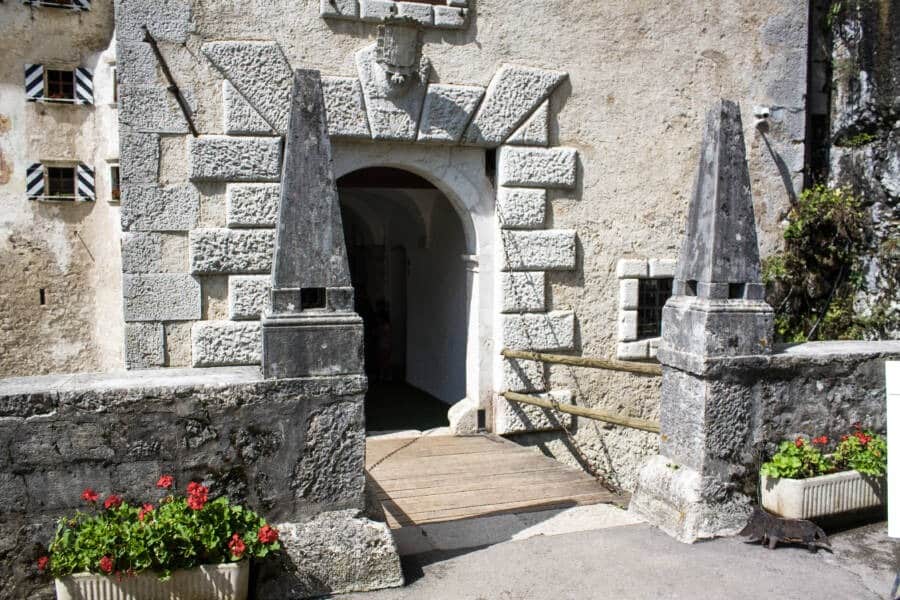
[760,471,885,519]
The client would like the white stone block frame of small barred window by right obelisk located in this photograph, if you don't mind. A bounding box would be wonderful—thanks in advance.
[616,258,675,360]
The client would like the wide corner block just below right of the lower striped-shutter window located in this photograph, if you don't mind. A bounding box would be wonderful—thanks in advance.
[122,185,200,231]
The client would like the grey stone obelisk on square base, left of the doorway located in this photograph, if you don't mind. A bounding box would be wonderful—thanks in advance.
[262,70,363,378]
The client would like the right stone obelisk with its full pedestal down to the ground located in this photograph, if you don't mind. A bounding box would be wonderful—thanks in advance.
[631,100,774,542]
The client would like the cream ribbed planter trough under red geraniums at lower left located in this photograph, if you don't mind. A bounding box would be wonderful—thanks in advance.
[56,560,250,600]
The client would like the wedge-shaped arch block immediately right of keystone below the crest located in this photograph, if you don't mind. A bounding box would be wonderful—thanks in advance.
[419,83,484,143]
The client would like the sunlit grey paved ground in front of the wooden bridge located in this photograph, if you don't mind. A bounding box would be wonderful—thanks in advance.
[340,513,900,600]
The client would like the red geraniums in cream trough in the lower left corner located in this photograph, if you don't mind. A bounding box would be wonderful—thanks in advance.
[38,475,280,600]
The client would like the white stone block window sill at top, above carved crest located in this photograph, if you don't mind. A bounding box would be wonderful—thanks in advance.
[319,0,471,29]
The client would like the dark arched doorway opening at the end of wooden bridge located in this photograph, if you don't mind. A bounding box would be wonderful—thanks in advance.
[337,167,468,431]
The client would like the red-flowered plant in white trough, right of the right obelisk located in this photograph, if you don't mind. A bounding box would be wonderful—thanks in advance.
[760,423,887,519]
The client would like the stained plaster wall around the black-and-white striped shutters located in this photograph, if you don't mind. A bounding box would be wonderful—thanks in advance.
[0,2,123,375]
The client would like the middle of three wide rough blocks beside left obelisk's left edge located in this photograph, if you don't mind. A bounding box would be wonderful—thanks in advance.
[190,229,275,274]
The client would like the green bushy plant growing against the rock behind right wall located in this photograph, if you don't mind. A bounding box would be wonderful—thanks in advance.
[763,185,900,342]
